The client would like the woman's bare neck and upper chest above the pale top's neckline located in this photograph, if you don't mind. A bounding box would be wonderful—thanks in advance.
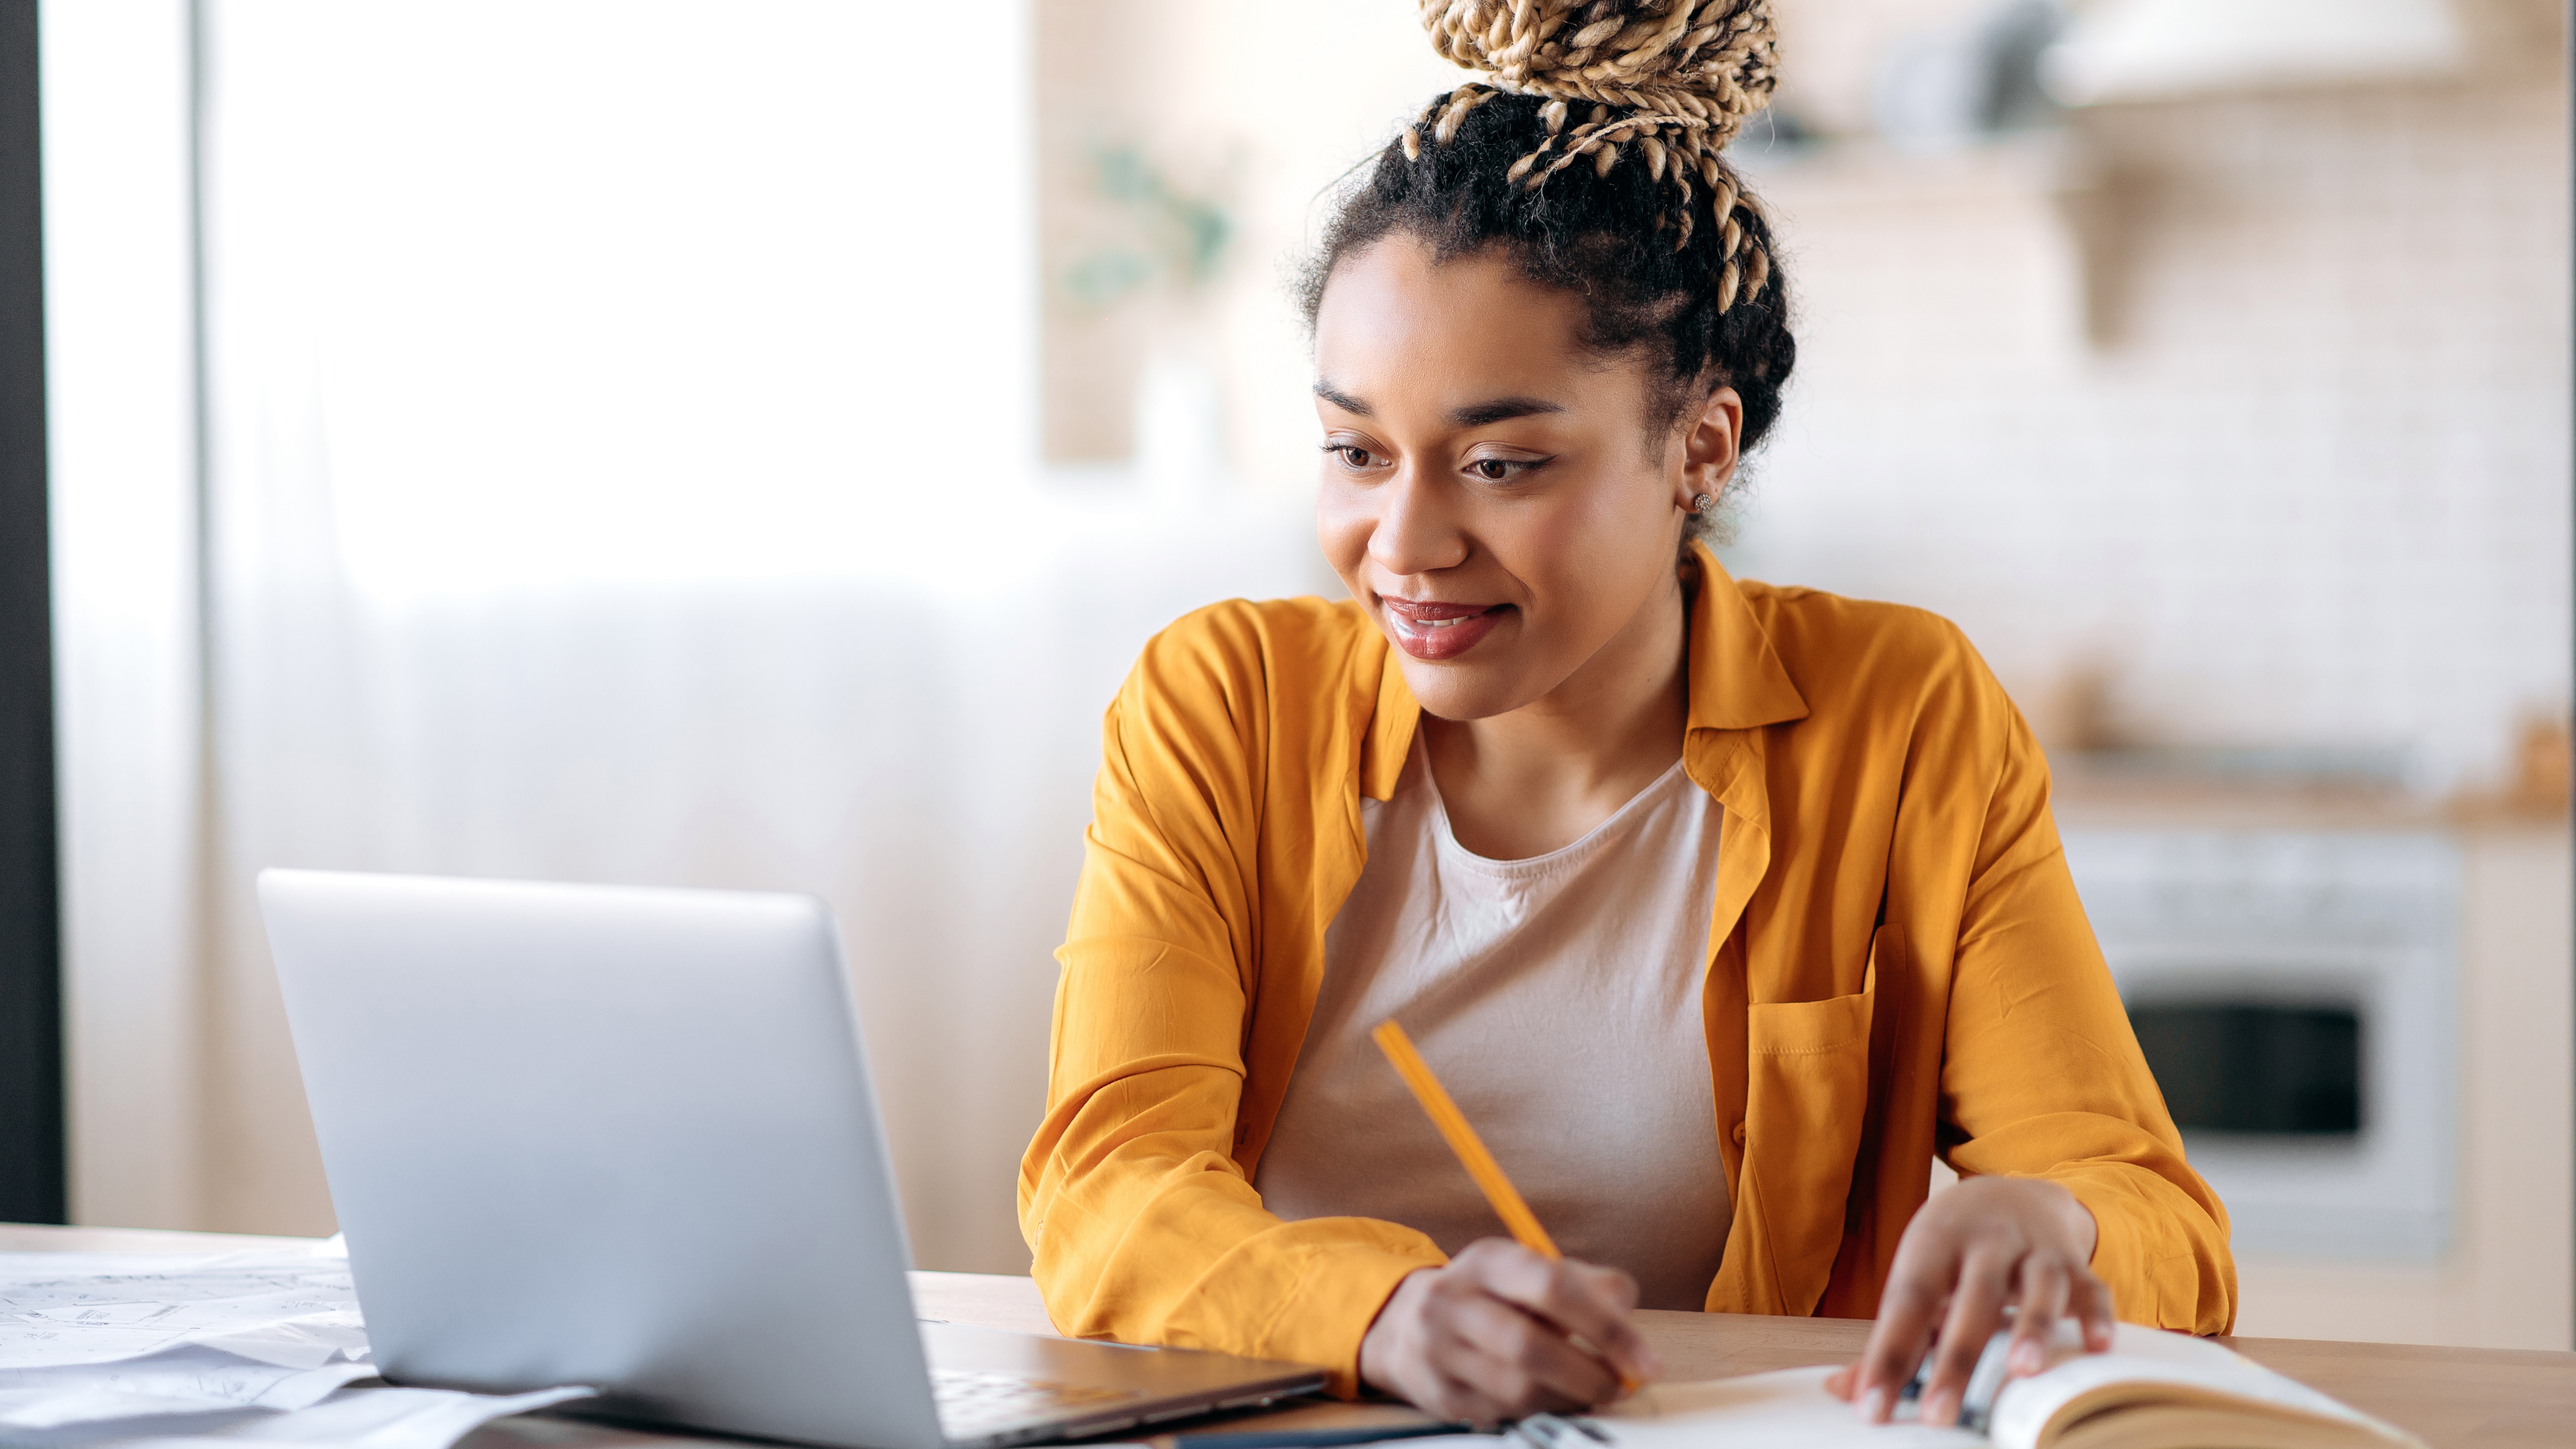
[1422,564,1690,861]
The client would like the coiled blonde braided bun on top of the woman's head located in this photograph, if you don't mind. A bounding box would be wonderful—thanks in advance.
[1422,0,1780,150]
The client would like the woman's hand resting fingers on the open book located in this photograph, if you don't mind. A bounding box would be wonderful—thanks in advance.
[1826,1178,2112,1423]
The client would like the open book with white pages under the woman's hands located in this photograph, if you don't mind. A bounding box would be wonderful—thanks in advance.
[1566,1323,2424,1449]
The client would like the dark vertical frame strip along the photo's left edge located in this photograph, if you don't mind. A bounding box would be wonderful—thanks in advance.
[0,0,70,1222]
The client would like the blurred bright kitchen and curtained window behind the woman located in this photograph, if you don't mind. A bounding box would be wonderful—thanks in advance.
[41,0,2576,1348]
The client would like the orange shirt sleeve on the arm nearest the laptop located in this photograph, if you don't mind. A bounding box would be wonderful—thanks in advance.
[1020,621,1443,1395]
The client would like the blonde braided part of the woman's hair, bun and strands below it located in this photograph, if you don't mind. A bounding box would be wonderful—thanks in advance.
[1404,0,1780,312]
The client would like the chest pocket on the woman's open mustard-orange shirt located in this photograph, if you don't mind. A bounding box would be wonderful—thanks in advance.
[1736,926,1901,1315]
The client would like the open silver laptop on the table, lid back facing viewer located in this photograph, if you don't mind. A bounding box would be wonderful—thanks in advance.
[260,871,1324,1449]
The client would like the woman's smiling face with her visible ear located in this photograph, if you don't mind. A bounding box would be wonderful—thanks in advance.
[1314,235,1741,719]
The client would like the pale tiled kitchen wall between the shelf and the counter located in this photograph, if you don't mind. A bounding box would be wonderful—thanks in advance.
[1734,65,2568,789]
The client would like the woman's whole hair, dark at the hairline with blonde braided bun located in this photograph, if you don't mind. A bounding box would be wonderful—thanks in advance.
[1301,0,1798,534]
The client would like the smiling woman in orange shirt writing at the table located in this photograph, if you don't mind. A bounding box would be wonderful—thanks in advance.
[1020,0,2236,1423]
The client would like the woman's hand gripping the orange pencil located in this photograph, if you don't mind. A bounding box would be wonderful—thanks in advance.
[1360,1238,1664,1428]
